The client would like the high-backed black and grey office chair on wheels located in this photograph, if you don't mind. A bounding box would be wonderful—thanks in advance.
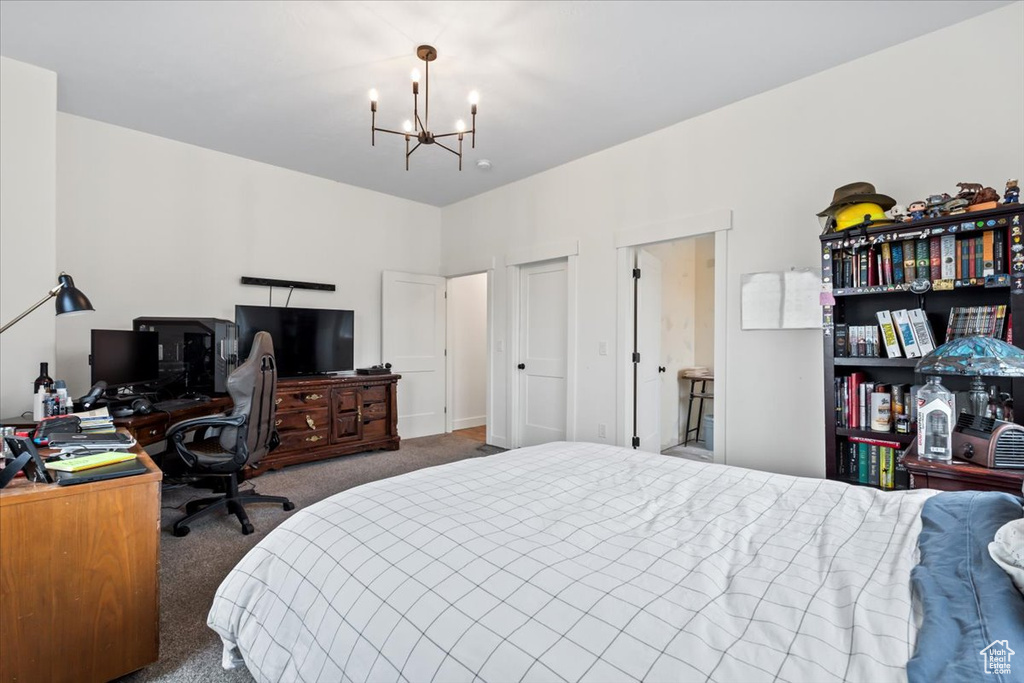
[167,332,295,537]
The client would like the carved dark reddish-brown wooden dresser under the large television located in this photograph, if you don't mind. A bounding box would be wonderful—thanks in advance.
[243,375,401,478]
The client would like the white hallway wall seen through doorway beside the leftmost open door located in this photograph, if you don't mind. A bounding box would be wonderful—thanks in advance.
[447,272,487,429]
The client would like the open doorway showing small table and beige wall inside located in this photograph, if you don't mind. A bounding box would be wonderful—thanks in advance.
[633,233,715,461]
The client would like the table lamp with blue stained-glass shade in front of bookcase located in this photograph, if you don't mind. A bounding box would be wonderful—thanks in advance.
[916,336,1024,416]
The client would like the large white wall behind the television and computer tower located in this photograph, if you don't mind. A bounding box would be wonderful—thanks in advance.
[56,114,440,395]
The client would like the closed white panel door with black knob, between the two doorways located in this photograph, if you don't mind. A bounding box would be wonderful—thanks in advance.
[517,259,568,445]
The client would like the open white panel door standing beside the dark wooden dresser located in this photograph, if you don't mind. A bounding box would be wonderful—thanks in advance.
[381,270,445,438]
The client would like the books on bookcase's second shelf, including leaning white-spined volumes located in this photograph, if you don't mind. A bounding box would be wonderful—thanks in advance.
[835,308,936,358]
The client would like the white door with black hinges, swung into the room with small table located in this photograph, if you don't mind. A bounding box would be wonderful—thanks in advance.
[636,249,662,453]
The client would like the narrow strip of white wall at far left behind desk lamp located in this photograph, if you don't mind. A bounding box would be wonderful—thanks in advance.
[0,57,56,418]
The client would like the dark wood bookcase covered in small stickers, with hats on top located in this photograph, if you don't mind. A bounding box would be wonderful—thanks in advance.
[820,204,1024,485]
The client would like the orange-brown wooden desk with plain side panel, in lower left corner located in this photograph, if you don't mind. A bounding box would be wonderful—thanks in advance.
[0,446,162,683]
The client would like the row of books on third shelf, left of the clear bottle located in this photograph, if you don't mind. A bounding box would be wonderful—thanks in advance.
[835,372,919,433]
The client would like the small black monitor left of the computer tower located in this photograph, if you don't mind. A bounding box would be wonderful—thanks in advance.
[90,330,160,387]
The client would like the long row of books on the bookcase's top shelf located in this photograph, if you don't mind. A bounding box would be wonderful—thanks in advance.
[833,230,1007,288]
